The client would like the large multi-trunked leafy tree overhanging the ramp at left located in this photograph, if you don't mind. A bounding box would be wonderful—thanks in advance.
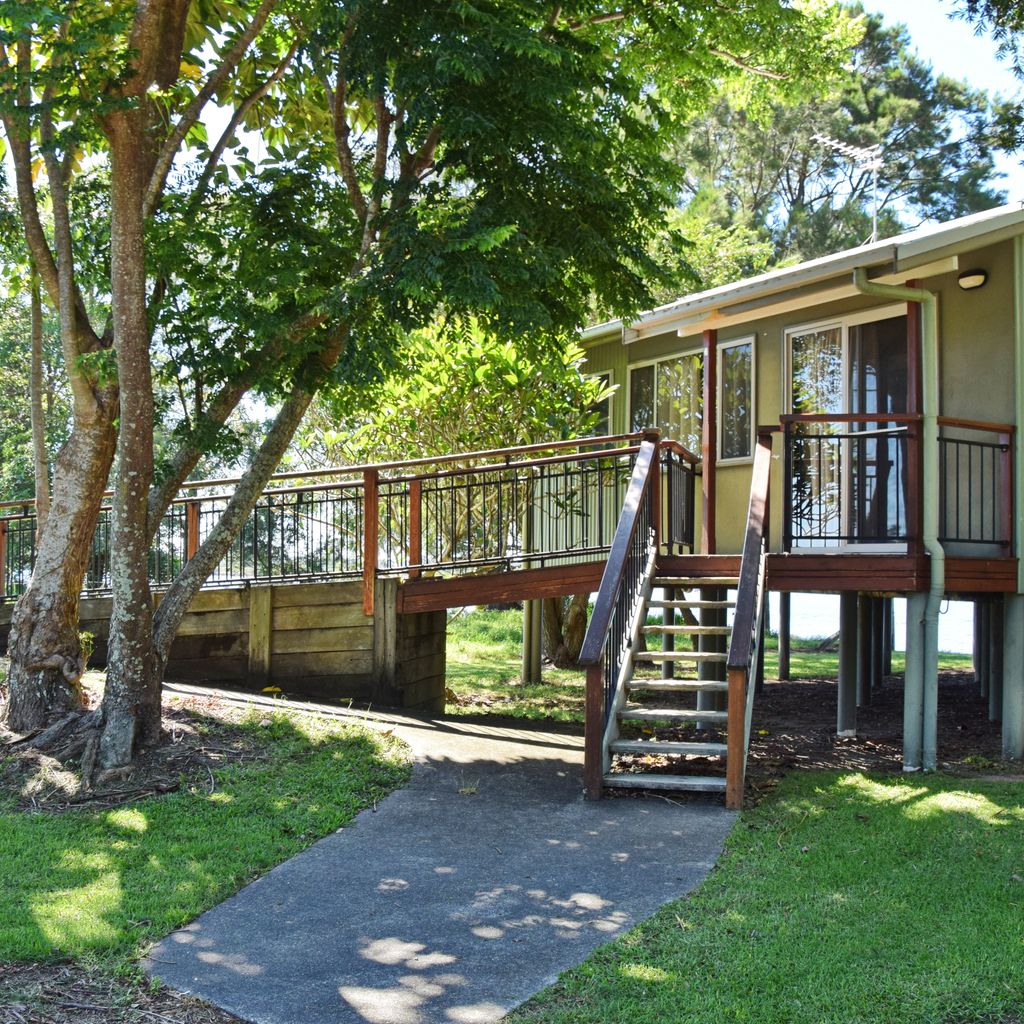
[0,0,847,766]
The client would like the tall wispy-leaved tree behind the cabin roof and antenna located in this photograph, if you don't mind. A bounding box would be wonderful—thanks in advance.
[675,6,1004,269]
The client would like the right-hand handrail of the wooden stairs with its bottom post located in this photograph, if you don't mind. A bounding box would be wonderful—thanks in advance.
[725,428,775,810]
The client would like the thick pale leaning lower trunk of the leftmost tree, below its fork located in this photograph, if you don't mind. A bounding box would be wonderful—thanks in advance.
[7,407,115,732]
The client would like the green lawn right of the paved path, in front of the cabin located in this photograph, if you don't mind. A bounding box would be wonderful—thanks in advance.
[510,772,1024,1024]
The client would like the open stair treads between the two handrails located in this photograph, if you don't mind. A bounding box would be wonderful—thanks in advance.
[603,571,738,793]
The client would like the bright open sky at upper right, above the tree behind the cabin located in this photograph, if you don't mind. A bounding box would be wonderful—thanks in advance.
[864,0,1024,202]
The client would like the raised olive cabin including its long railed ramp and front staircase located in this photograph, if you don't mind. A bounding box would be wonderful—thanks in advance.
[0,201,1024,807]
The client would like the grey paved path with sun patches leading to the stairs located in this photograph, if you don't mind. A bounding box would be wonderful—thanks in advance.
[148,688,733,1024]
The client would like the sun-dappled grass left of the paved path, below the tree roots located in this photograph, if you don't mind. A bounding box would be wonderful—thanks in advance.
[0,711,409,967]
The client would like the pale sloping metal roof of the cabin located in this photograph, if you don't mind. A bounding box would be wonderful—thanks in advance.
[583,203,1024,343]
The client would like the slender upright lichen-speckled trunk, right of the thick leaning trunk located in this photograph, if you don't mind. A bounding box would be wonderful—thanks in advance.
[99,108,161,768]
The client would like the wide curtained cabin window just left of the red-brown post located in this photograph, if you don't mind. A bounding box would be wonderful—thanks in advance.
[630,352,703,452]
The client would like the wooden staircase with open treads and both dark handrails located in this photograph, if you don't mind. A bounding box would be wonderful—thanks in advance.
[580,429,773,809]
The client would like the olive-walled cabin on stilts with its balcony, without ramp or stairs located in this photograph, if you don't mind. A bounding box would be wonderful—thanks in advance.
[583,206,1024,798]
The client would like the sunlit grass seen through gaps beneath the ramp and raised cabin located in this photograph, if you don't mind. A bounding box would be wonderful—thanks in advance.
[447,610,972,722]
